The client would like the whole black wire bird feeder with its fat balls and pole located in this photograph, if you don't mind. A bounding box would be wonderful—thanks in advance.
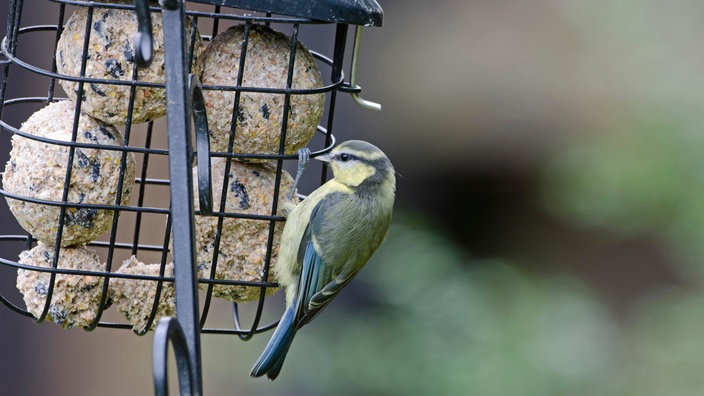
[0,0,383,394]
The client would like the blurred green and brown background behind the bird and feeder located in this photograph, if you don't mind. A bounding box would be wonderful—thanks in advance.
[0,0,704,396]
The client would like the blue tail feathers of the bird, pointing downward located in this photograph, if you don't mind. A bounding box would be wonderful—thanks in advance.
[250,306,296,381]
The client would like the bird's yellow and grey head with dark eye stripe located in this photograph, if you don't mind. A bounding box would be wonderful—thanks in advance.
[316,140,395,188]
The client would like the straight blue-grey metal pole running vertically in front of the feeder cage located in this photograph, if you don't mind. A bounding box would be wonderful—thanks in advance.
[155,0,202,395]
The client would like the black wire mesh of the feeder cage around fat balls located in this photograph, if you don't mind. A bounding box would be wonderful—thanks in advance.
[0,0,352,339]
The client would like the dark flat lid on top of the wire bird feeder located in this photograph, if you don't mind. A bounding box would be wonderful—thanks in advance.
[193,0,384,26]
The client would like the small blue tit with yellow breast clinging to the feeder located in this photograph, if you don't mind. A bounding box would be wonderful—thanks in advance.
[250,140,396,381]
